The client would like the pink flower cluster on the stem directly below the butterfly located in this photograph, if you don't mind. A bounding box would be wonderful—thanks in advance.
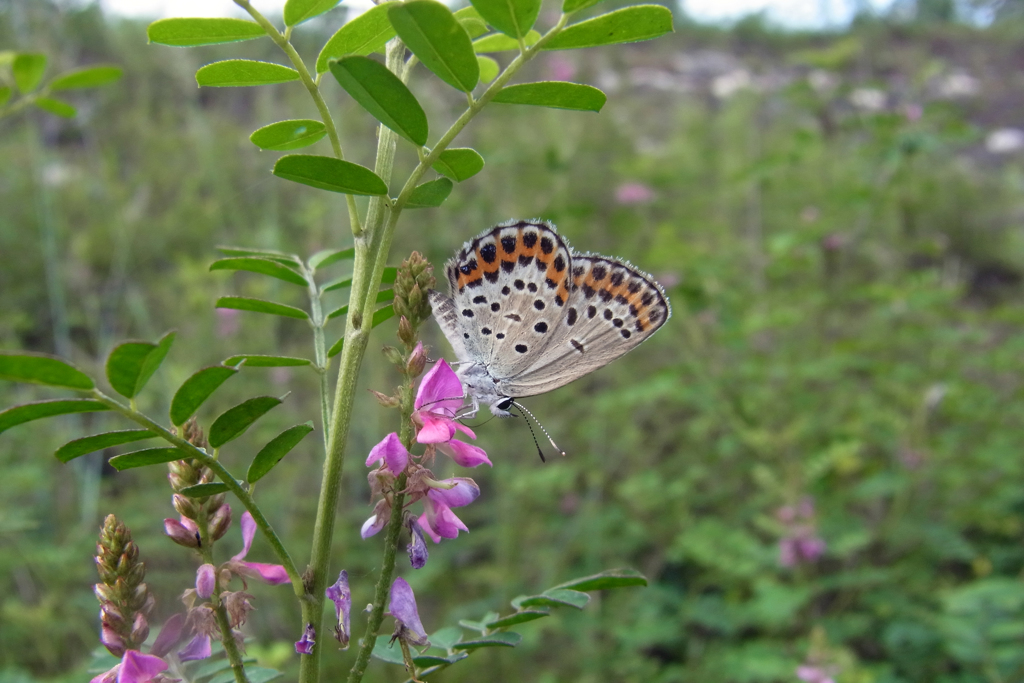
[361,356,490,552]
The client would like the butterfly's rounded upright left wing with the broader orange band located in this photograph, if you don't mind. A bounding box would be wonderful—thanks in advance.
[431,221,571,381]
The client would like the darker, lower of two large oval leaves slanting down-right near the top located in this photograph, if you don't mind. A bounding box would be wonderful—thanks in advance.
[331,55,427,147]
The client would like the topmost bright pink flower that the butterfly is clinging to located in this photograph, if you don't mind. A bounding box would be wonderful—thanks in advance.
[413,358,490,467]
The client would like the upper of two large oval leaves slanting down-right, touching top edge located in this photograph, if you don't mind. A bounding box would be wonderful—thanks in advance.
[388,0,480,92]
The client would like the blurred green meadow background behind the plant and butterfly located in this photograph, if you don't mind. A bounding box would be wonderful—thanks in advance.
[0,0,1024,683]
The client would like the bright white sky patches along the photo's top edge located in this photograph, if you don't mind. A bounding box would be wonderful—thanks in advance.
[101,0,892,27]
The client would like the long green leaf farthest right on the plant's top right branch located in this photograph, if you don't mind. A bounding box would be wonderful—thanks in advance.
[544,5,672,50]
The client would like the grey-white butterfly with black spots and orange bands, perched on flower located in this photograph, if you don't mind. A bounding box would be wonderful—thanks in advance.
[429,220,672,417]
